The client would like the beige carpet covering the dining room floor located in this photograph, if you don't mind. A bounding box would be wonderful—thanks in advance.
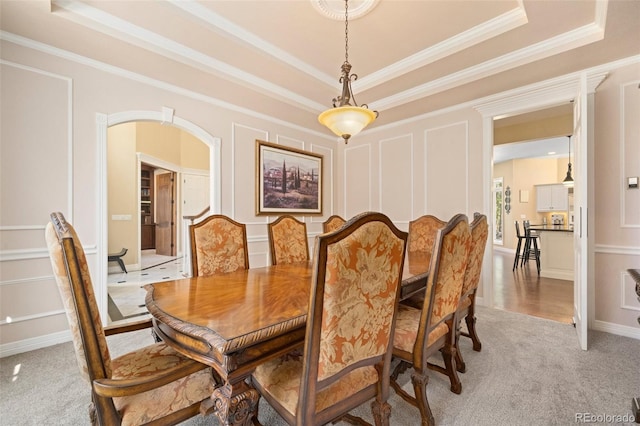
[0,307,640,426]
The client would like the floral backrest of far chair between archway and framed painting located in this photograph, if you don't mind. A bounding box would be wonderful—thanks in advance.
[189,215,249,277]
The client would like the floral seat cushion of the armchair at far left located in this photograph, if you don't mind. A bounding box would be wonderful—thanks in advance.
[111,343,213,425]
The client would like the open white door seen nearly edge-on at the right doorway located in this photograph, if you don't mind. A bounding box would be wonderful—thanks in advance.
[569,74,590,350]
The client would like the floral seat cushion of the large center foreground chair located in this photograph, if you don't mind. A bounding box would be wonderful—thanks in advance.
[253,351,378,416]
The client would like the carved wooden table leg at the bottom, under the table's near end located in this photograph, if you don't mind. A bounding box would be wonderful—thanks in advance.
[200,380,260,426]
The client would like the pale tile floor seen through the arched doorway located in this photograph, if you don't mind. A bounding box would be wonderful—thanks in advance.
[107,257,184,324]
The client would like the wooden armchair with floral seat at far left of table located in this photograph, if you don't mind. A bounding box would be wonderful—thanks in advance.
[45,212,214,426]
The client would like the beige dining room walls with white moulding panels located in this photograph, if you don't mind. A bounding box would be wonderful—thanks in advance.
[0,41,640,355]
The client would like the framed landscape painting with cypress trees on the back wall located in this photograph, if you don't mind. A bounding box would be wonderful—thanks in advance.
[256,140,323,215]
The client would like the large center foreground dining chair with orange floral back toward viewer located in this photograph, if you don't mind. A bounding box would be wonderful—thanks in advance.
[251,212,407,425]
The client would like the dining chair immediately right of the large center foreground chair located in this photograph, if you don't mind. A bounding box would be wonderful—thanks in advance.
[391,214,471,425]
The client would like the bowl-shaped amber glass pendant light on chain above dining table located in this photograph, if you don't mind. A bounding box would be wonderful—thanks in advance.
[318,0,378,144]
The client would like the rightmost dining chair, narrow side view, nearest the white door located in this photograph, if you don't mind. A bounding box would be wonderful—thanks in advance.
[456,213,489,373]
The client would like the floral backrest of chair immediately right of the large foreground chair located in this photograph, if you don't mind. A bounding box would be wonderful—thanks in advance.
[416,214,471,336]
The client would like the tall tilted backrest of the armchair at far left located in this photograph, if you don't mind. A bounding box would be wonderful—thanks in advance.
[45,212,112,383]
